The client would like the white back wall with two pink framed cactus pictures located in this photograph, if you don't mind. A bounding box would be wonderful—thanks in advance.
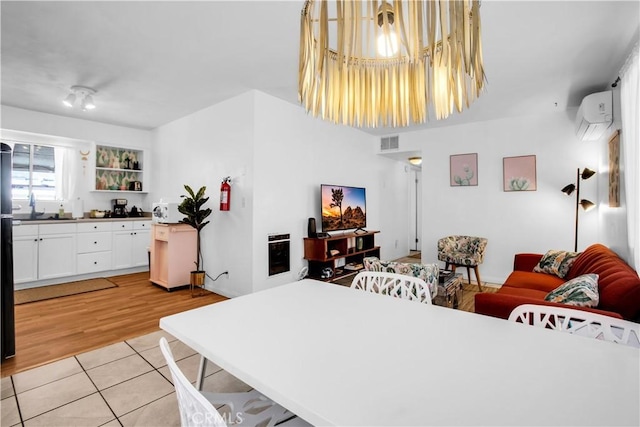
[400,110,607,283]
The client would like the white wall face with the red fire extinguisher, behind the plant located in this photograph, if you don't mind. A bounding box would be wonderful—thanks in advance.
[151,92,254,296]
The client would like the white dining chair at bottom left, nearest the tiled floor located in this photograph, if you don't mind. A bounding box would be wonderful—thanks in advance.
[160,337,309,427]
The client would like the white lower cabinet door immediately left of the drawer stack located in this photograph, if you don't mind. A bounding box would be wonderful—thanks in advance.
[38,233,76,279]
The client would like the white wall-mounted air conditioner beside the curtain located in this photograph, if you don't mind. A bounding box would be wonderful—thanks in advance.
[576,90,613,141]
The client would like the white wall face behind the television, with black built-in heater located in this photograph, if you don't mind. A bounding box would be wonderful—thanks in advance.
[253,92,408,290]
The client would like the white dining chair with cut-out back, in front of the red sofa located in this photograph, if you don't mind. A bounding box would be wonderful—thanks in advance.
[509,304,640,348]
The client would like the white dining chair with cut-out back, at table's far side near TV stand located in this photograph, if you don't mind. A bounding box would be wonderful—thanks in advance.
[351,271,437,304]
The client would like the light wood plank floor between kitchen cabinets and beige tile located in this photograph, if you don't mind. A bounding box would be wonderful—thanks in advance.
[1,272,226,377]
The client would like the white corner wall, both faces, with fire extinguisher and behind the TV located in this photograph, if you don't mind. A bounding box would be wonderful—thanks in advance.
[152,91,408,296]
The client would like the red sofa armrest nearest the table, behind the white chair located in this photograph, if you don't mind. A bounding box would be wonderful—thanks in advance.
[475,293,622,319]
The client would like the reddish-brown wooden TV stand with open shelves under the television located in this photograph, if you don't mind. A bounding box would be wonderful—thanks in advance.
[304,231,380,280]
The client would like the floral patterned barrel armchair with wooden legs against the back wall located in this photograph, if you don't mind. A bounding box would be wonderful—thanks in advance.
[438,236,487,291]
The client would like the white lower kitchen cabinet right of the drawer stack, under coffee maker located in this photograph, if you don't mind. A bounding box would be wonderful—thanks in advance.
[112,221,151,269]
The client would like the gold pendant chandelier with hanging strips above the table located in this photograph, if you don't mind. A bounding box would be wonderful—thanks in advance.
[298,0,485,127]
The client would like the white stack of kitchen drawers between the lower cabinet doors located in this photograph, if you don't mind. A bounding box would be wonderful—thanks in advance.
[77,222,112,274]
